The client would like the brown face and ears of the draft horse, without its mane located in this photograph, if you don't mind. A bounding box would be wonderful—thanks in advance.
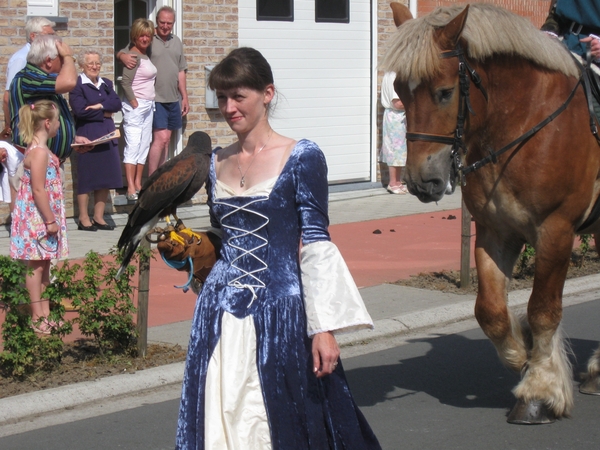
[392,3,468,202]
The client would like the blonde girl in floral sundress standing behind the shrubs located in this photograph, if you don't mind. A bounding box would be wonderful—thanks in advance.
[10,100,69,334]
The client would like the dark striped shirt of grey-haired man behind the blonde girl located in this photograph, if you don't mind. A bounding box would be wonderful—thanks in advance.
[9,63,75,162]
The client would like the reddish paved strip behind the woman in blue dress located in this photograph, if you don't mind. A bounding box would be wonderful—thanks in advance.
[0,210,475,340]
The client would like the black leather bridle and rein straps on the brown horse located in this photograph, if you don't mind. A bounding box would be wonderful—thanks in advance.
[406,43,581,188]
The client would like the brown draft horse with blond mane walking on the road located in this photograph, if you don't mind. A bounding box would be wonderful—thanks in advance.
[382,3,600,424]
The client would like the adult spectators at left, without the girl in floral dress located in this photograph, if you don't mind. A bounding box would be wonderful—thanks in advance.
[0,6,189,231]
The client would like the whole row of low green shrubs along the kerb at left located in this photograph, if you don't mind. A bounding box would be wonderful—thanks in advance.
[0,249,143,378]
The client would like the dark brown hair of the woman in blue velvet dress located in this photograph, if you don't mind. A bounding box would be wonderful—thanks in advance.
[208,47,273,91]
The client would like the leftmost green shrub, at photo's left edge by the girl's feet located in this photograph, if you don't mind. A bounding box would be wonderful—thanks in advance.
[0,256,68,378]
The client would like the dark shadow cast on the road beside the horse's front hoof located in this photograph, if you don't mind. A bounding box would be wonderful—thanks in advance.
[345,330,597,412]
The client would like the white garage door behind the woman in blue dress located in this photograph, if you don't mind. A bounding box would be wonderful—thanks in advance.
[238,0,372,183]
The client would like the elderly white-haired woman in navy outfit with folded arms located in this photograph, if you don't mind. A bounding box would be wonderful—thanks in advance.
[69,50,123,231]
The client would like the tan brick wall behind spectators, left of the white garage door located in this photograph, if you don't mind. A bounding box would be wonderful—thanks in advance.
[0,0,238,224]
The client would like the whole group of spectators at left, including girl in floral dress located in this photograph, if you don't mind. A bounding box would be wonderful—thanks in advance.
[0,7,189,334]
